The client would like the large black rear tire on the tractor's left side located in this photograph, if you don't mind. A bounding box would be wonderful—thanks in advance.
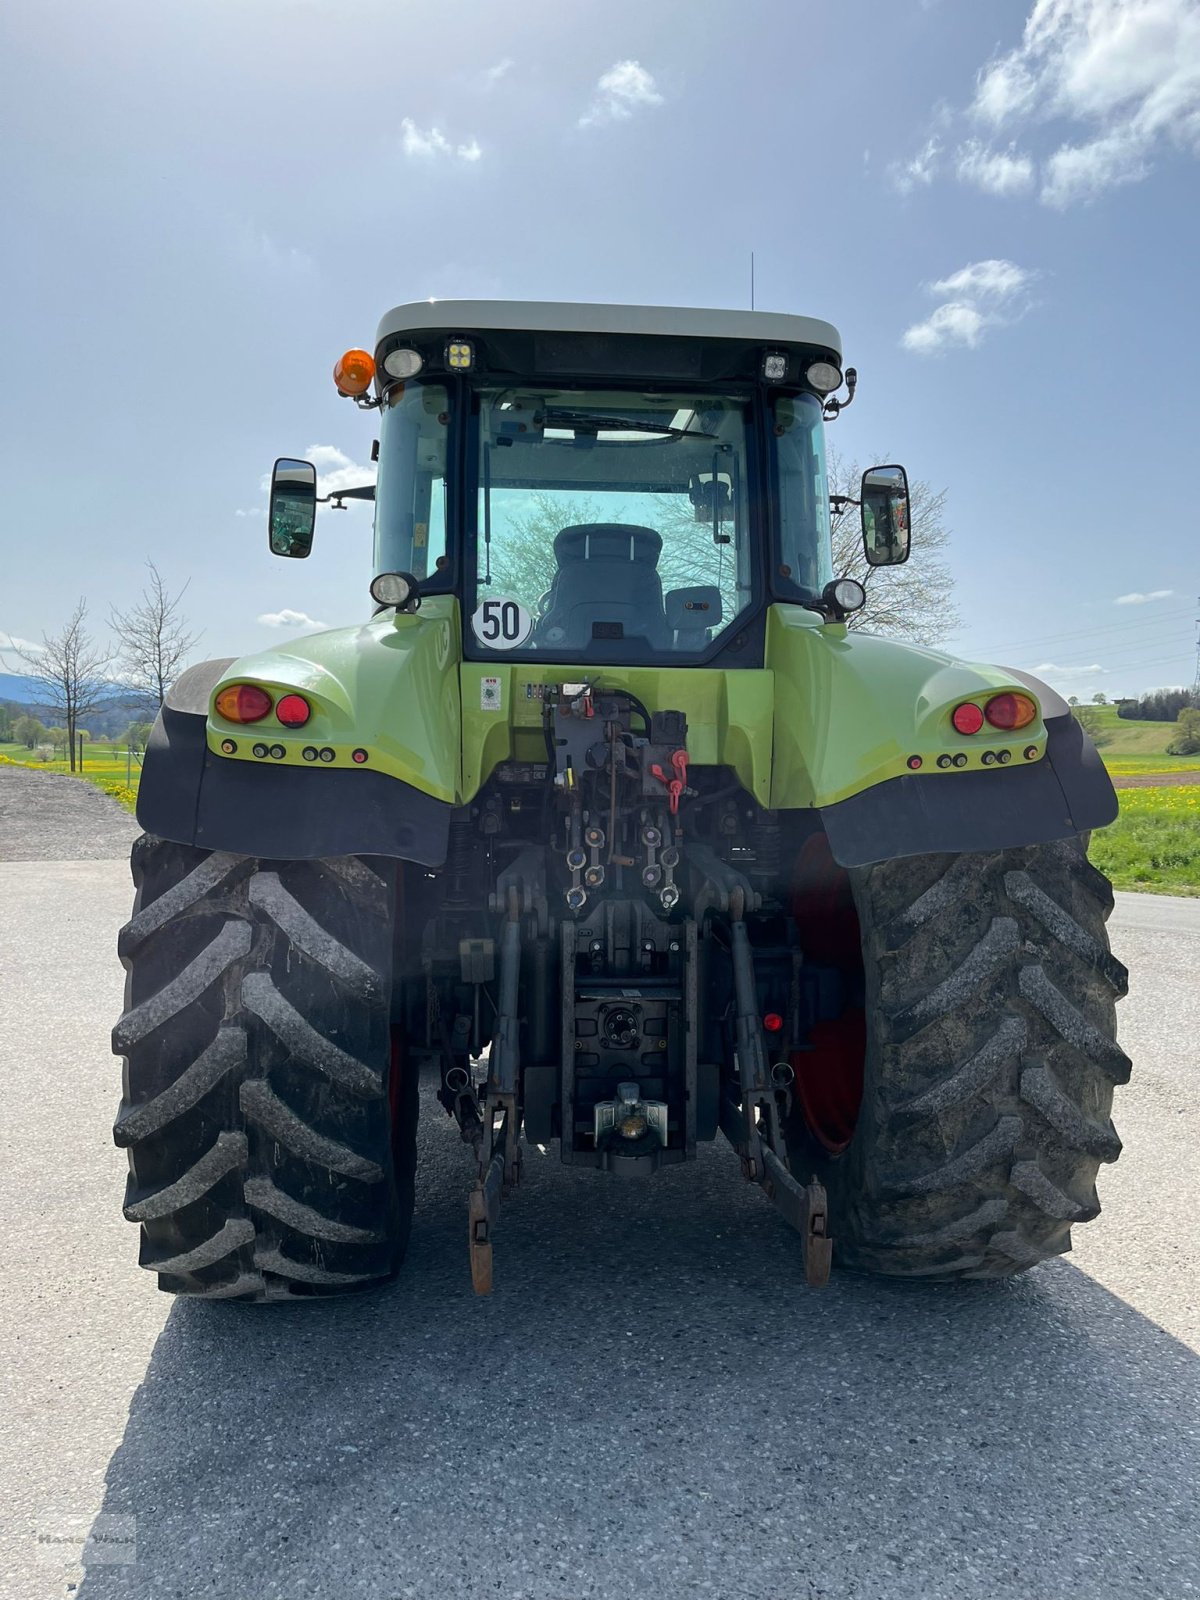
[114,835,418,1301]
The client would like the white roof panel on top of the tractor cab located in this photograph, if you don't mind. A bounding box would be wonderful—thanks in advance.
[374,299,842,358]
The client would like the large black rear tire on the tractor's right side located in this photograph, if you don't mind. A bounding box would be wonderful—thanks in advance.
[792,840,1130,1278]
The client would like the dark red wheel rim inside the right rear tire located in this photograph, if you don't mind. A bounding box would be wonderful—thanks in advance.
[789,834,867,1155]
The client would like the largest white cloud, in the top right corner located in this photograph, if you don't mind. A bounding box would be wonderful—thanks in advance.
[971,0,1200,208]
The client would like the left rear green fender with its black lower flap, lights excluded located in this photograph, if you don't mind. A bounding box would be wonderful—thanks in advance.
[138,600,461,866]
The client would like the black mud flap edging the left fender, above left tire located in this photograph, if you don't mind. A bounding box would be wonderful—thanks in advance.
[138,661,451,867]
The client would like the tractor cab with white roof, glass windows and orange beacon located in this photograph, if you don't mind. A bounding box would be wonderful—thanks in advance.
[272,301,902,667]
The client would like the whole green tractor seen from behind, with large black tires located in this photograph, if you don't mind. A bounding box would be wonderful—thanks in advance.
[114,302,1130,1301]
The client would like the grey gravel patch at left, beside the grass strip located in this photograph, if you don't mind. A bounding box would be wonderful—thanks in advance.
[0,766,141,861]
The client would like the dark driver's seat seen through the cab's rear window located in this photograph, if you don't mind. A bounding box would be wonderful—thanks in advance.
[538,522,670,650]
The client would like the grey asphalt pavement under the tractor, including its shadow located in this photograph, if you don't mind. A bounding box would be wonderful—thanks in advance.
[0,861,1200,1600]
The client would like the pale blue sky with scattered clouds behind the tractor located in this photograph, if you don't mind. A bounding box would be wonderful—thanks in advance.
[0,0,1200,698]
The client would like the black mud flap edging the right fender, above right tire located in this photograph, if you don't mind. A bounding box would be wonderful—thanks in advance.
[821,715,1117,867]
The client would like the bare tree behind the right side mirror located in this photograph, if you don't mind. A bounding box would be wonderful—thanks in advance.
[829,450,960,645]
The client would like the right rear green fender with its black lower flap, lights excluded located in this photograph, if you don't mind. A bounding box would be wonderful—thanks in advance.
[768,606,1117,867]
